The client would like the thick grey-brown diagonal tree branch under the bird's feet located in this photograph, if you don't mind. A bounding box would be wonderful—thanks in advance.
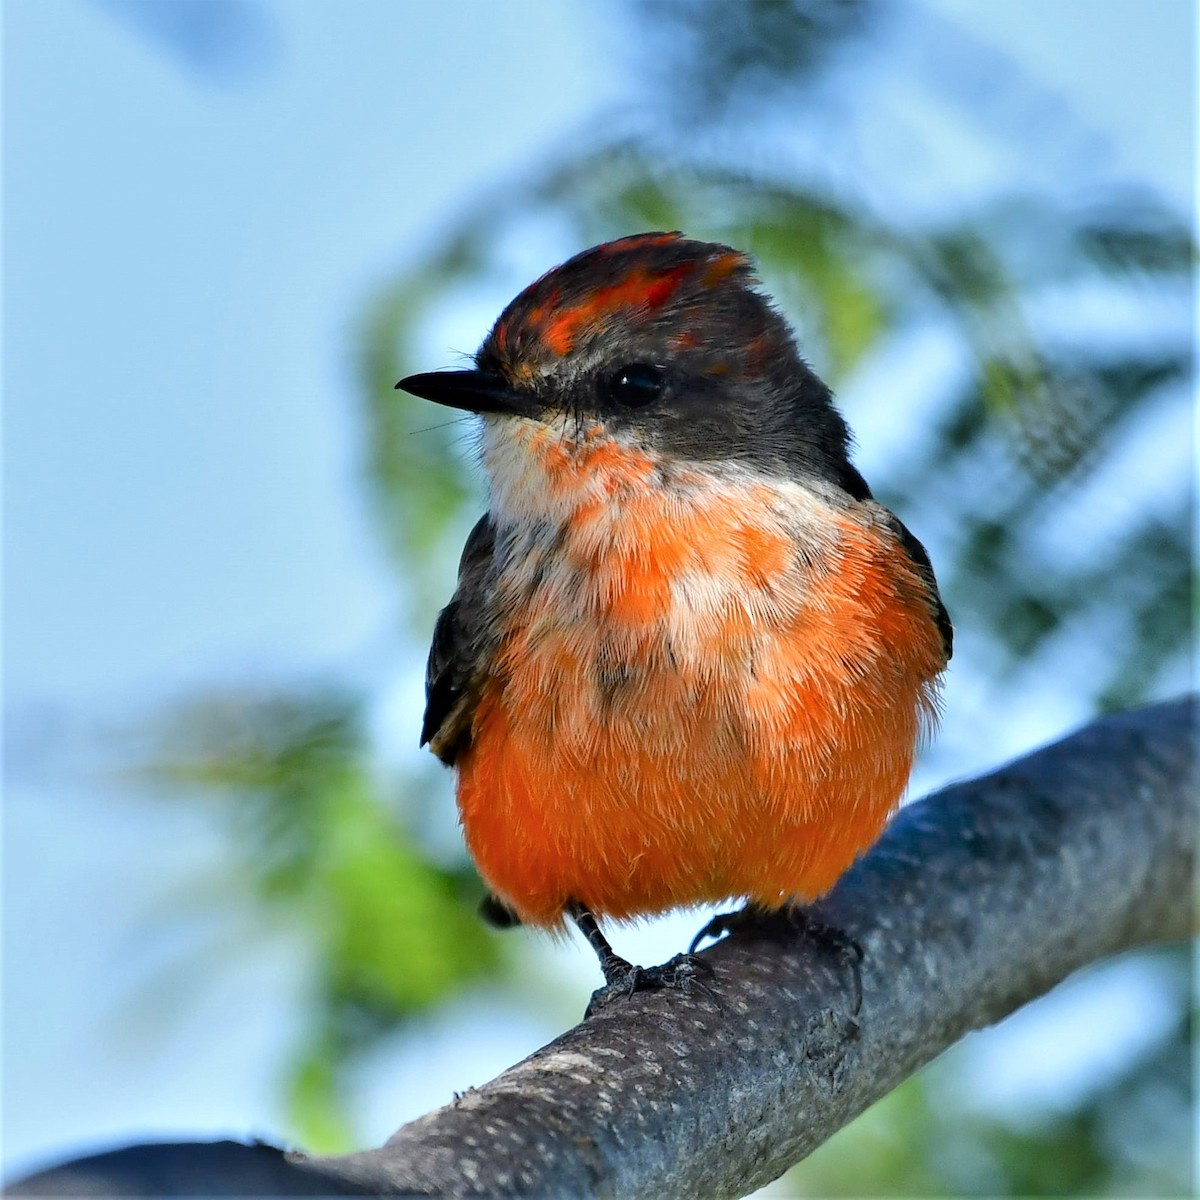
[16,701,1196,1198]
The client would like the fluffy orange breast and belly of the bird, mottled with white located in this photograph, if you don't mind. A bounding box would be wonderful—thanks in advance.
[457,432,943,925]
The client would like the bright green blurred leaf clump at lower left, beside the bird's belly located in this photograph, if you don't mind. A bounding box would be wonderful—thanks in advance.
[150,690,498,1150]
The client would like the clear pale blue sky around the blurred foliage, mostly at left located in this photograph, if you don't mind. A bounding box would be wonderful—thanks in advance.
[4,0,1194,1180]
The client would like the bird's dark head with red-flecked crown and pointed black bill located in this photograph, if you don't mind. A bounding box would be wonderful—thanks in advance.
[397,233,865,494]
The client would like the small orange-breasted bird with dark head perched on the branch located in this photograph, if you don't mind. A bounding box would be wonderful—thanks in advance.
[396,232,953,997]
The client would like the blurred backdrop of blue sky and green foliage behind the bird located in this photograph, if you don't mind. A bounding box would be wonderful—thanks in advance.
[2,0,1195,1195]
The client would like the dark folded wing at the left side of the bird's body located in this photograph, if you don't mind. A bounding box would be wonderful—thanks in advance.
[421,514,497,766]
